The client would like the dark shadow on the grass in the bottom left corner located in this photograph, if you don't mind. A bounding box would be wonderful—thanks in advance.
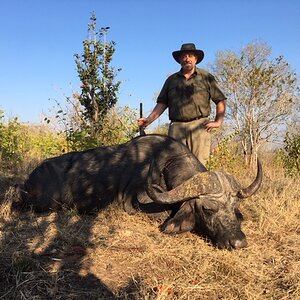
[0,186,143,300]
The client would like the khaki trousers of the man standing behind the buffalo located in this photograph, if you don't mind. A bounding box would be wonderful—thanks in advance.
[168,118,211,165]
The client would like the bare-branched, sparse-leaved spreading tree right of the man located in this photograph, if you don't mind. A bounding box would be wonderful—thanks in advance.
[213,42,299,163]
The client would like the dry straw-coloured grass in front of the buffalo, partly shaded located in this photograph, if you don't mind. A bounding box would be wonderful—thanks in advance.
[0,159,300,300]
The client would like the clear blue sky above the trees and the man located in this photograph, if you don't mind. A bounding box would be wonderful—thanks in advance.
[0,0,300,123]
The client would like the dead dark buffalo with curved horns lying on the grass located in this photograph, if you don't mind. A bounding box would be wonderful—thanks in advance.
[17,135,262,248]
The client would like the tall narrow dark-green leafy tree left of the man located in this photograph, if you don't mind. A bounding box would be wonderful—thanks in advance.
[75,14,120,136]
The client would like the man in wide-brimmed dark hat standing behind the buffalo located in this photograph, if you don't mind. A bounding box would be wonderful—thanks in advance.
[138,43,226,165]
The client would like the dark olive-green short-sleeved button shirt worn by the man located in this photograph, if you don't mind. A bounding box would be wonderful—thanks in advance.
[157,68,226,121]
